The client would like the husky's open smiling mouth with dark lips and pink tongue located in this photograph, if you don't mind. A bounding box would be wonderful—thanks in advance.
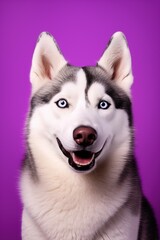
[57,138,103,172]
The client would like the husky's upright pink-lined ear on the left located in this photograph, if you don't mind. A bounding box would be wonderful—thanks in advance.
[30,32,66,94]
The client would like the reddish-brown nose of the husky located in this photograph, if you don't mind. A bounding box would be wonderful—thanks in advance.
[73,126,97,147]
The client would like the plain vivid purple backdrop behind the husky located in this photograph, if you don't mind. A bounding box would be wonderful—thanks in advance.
[0,0,160,240]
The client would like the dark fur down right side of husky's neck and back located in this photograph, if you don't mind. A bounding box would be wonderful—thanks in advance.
[118,155,159,235]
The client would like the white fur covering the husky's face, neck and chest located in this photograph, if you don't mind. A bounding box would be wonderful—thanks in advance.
[21,32,139,240]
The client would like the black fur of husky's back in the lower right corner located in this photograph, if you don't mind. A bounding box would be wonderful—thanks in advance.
[138,197,159,240]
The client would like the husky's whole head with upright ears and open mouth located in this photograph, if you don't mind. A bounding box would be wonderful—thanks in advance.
[29,33,133,172]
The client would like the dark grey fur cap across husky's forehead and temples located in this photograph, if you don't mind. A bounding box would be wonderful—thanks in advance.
[25,64,132,179]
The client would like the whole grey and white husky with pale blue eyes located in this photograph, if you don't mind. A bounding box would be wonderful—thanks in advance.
[20,32,158,240]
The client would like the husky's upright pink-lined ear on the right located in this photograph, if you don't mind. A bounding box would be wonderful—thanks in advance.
[98,32,133,95]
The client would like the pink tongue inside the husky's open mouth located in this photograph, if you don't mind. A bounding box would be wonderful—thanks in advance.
[71,152,94,166]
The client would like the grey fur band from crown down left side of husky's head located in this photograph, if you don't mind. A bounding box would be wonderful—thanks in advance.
[22,65,79,178]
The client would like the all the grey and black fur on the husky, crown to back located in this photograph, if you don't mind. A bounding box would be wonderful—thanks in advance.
[22,33,158,240]
